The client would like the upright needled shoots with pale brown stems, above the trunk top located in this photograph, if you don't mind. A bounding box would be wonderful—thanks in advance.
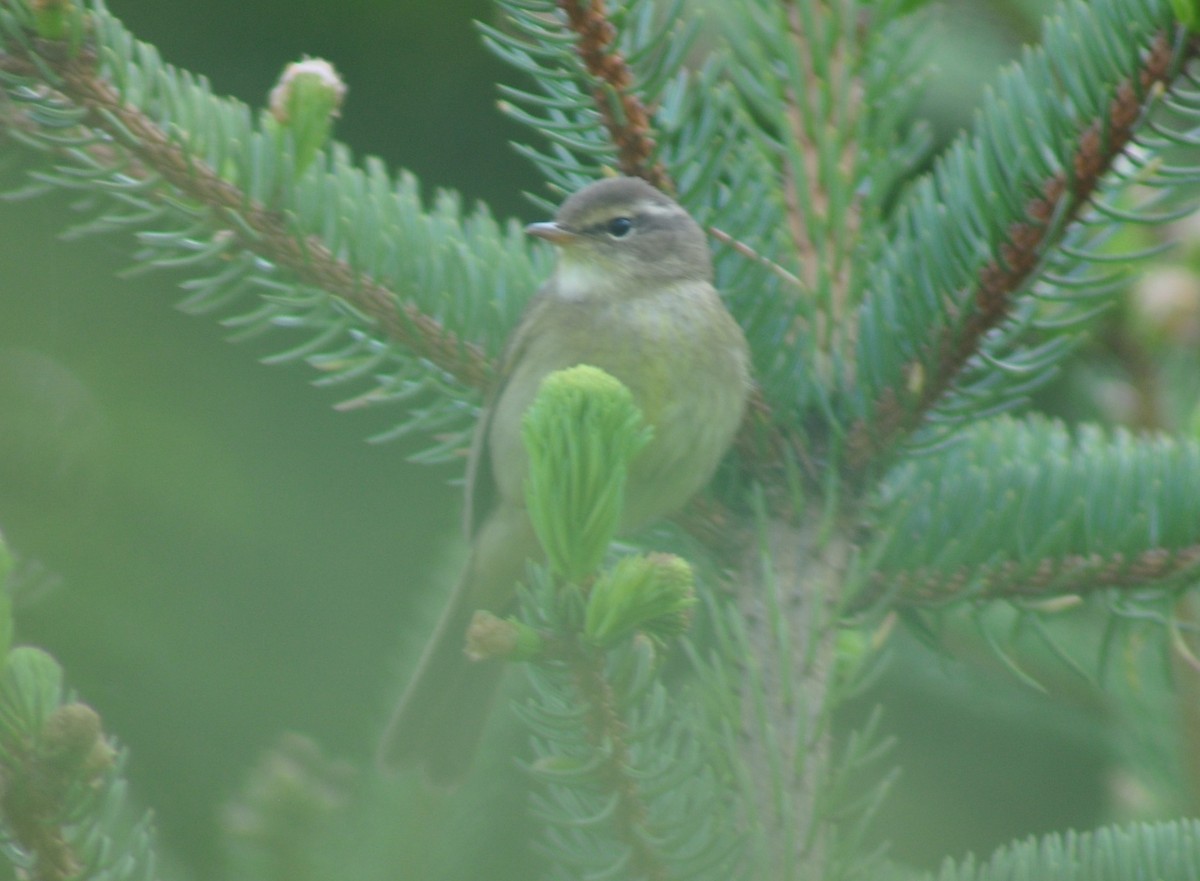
[714,0,929,391]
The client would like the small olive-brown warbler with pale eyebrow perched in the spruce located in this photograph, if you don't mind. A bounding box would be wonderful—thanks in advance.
[379,178,750,784]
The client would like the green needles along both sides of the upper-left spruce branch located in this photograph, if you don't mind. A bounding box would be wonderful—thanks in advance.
[0,4,544,461]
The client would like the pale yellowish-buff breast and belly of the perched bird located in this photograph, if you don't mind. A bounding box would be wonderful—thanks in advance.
[490,280,749,529]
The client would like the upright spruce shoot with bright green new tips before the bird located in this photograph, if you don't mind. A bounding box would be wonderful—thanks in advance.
[520,365,737,881]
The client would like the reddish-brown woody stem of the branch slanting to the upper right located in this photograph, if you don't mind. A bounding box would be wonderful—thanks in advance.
[850,34,1172,467]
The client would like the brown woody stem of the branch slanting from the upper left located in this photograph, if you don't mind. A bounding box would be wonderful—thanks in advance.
[0,50,493,388]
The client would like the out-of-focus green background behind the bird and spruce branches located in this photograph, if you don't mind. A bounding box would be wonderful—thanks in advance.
[0,0,1190,874]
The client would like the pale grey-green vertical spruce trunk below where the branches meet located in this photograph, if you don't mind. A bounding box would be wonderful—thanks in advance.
[710,513,850,879]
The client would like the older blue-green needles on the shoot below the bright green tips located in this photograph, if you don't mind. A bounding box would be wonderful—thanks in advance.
[517,568,742,880]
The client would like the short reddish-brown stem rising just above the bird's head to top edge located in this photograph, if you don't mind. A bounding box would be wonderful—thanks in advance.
[558,0,674,193]
